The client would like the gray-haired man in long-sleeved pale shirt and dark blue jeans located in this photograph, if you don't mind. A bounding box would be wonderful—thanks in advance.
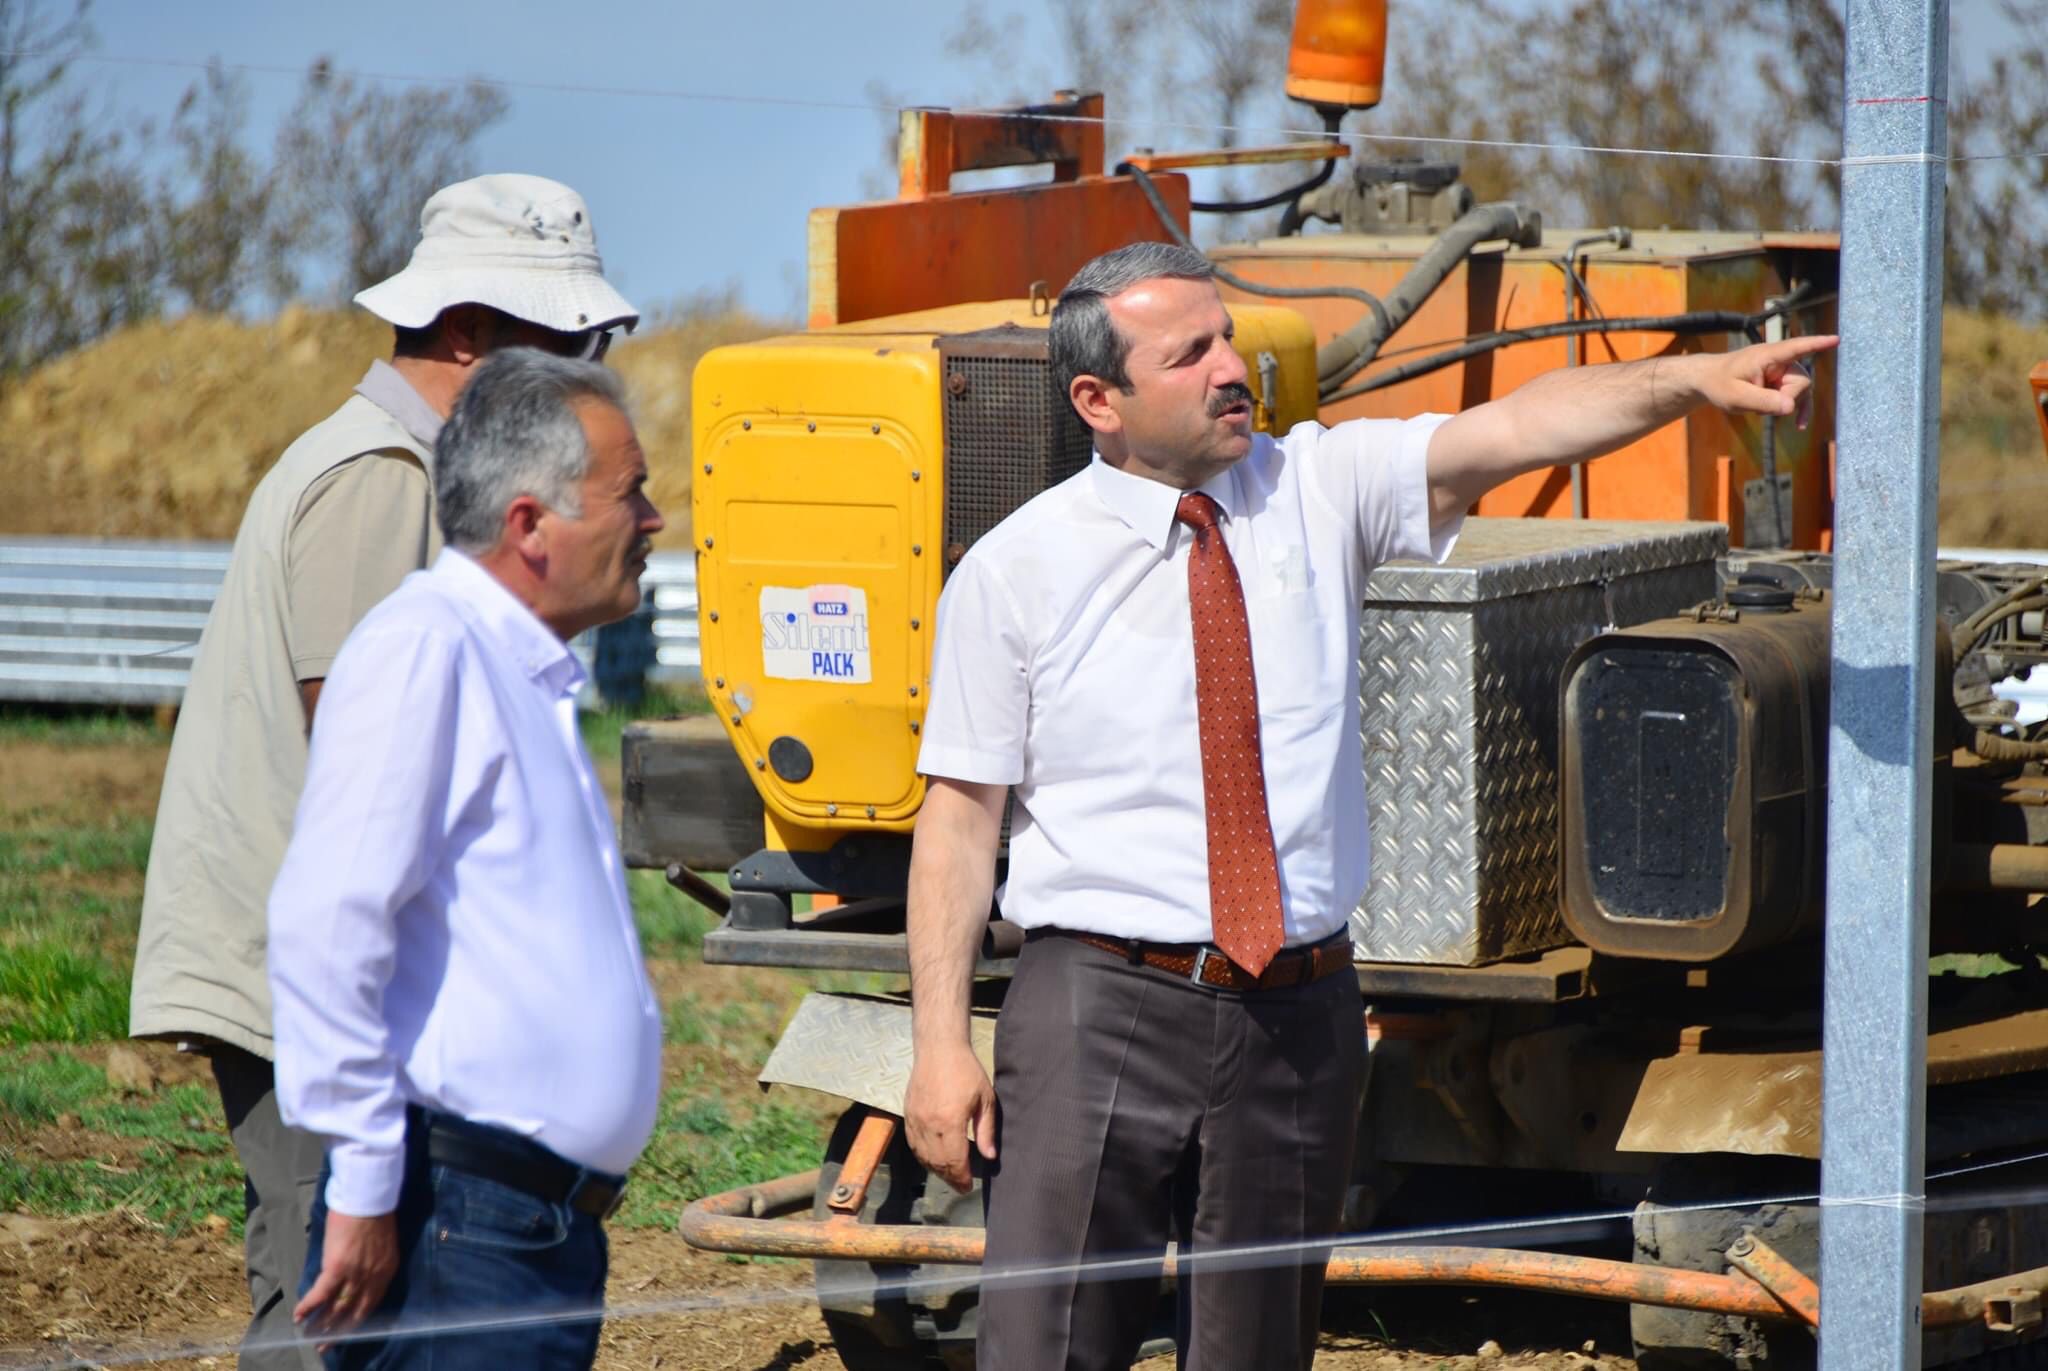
[270,348,662,1371]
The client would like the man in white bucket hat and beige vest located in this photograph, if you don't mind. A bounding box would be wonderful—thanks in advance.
[129,174,639,1371]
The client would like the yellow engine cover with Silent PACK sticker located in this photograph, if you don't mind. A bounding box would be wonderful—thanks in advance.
[690,299,1315,850]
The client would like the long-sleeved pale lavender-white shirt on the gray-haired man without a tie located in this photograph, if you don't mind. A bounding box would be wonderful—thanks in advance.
[270,549,662,1217]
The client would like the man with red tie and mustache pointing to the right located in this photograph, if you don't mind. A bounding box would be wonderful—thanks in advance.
[905,244,1833,1371]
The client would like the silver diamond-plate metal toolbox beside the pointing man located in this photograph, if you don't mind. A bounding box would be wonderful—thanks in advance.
[1352,518,1729,965]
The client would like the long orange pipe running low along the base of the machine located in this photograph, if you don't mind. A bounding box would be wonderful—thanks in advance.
[678,1170,2048,1328]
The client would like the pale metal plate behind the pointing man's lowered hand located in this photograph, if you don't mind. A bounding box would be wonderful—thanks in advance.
[756,994,995,1115]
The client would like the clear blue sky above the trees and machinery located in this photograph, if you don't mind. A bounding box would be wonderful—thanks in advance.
[80,0,2015,316]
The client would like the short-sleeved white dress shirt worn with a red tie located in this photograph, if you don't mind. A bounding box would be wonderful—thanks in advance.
[918,414,1462,947]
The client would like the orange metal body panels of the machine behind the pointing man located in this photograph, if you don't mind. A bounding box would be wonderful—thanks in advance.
[809,92,1843,549]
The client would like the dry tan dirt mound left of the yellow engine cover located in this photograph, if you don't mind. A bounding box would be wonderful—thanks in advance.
[0,305,774,547]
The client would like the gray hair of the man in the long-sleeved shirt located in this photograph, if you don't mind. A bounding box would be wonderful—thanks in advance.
[434,348,627,553]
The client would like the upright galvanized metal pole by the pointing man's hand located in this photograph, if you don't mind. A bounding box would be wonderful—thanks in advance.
[1821,0,1948,1371]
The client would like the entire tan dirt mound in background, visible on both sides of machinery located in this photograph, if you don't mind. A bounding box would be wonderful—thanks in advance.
[0,307,2048,547]
